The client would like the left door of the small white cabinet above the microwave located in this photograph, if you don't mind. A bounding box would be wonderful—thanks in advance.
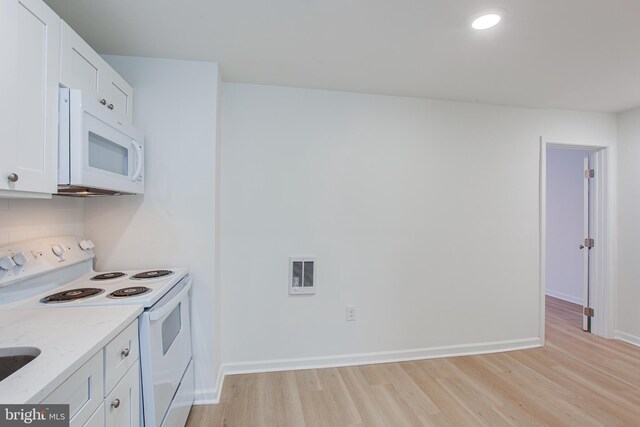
[60,21,106,96]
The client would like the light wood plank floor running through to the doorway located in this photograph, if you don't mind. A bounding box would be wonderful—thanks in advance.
[187,298,640,427]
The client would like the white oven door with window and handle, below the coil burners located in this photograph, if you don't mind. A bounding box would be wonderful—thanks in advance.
[140,276,191,427]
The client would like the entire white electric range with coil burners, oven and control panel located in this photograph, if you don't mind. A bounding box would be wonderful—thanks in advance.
[0,236,194,427]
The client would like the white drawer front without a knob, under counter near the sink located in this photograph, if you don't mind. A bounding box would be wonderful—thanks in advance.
[42,351,104,427]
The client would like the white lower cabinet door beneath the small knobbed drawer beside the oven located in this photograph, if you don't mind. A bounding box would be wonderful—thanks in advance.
[105,363,140,427]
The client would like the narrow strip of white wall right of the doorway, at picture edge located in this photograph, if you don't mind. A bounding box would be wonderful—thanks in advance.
[616,108,640,345]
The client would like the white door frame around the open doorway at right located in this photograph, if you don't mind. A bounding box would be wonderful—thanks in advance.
[539,136,617,345]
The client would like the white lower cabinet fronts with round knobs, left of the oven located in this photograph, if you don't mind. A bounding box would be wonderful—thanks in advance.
[42,319,140,427]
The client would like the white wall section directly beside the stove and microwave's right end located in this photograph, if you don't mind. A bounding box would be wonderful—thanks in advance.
[85,56,221,401]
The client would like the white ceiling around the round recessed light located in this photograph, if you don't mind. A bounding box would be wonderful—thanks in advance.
[45,0,640,112]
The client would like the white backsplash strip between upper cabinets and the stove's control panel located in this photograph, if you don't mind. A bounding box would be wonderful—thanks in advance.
[0,196,84,245]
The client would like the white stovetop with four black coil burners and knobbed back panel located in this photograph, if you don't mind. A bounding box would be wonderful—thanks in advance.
[0,236,188,309]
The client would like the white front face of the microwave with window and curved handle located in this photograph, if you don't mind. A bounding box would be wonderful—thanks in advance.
[69,90,144,194]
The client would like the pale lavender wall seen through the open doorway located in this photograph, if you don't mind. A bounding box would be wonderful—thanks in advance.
[546,148,589,305]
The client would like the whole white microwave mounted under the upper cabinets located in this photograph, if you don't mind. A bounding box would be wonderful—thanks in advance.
[58,88,144,197]
